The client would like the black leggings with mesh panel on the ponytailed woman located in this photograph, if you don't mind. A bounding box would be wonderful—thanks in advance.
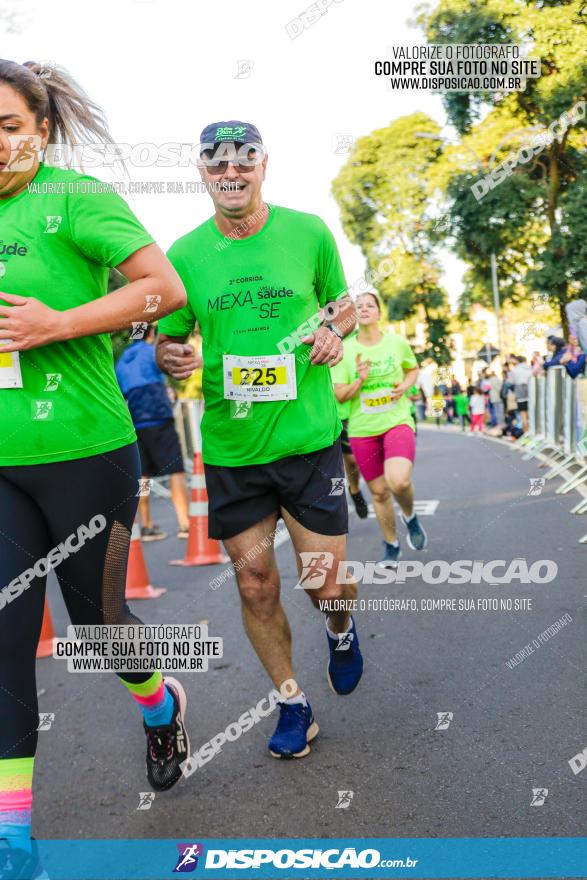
[0,444,151,758]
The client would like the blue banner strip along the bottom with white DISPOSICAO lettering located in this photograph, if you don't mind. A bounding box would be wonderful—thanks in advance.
[18,837,587,880]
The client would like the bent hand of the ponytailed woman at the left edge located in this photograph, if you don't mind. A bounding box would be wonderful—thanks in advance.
[0,291,64,353]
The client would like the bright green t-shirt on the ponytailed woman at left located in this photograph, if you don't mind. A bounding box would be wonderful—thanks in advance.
[0,165,153,466]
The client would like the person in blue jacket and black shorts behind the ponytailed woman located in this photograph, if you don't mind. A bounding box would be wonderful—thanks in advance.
[115,325,189,541]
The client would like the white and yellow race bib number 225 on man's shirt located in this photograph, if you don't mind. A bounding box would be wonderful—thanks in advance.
[223,354,297,402]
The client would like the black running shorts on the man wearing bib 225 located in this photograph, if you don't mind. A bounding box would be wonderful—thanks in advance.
[204,438,348,540]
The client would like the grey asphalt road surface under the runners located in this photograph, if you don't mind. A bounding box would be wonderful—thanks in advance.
[33,428,587,852]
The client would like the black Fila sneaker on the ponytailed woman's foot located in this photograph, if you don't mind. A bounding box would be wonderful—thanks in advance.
[143,678,190,791]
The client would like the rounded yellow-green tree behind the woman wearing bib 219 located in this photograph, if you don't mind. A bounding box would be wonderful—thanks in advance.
[332,113,450,363]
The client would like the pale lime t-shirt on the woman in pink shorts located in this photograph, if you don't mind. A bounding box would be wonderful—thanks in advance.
[332,333,418,437]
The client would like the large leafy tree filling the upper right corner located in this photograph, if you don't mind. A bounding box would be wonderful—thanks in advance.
[418,0,587,325]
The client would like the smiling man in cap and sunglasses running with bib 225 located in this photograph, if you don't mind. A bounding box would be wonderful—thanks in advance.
[158,121,363,758]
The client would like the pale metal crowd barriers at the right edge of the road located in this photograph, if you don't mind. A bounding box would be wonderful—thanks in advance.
[516,367,587,544]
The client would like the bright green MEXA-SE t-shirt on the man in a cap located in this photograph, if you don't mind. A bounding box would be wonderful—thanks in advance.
[159,206,346,466]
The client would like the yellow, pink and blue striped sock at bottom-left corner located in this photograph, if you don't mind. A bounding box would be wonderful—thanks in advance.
[0,758,35,852]
